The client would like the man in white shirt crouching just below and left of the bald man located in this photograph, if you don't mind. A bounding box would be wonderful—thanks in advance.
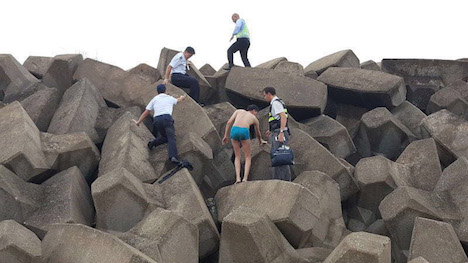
[163,47,200,103]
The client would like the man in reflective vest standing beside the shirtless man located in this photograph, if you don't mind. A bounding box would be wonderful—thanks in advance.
[263,87,291,181]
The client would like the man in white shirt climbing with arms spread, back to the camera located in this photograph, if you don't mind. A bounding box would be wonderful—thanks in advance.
[135,84,185,163]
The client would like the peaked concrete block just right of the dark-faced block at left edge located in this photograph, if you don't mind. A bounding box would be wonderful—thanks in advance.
[47,79,106,143]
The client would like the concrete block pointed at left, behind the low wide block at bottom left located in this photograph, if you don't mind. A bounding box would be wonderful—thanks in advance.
[118,208,198,263]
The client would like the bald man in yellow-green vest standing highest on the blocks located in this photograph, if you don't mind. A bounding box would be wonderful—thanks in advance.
[225,14,250,70]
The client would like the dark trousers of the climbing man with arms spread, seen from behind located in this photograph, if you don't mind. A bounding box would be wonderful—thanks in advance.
[150,114,177,159]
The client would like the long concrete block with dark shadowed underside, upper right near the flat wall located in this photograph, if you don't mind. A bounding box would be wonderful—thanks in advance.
[317,68,406,109]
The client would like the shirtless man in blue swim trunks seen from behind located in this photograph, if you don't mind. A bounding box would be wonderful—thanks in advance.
[223,105,267,183]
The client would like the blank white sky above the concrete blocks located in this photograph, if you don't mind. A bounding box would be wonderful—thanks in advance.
[0,0,468,69]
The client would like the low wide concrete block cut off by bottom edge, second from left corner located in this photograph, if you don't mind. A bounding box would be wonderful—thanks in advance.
[42,224,158,263]
